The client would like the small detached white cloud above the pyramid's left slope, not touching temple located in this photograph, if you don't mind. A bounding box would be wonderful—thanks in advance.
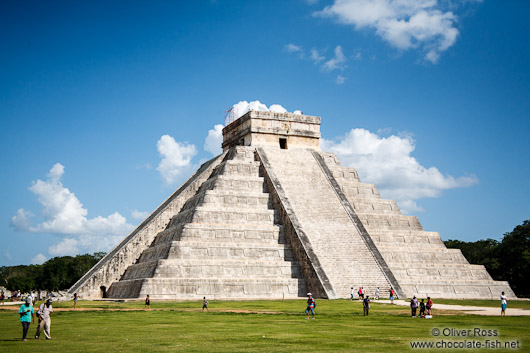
[156,135,197,184]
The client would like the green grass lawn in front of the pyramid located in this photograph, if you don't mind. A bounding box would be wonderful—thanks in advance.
[0,300,530,353]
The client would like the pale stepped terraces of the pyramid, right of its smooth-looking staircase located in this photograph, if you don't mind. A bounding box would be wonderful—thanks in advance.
[321,153,516,299]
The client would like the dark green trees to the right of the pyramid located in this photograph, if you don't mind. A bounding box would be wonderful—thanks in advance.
[444,220,530,297]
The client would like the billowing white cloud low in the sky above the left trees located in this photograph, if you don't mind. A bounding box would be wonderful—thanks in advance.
[10,163,133,255]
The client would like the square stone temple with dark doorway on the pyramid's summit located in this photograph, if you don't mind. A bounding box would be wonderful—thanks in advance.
[223,110,320,151]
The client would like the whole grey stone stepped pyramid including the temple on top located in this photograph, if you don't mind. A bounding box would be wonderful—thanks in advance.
[69,111,515,299]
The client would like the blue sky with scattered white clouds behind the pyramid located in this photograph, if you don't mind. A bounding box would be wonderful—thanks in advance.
[0,0,530,266]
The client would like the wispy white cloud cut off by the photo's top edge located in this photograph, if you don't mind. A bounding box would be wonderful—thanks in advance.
[315,0,459,63]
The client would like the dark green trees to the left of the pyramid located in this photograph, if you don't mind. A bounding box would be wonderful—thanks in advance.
[0,252,105,293]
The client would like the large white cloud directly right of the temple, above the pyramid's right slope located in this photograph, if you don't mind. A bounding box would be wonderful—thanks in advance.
[321,129,478,213]
